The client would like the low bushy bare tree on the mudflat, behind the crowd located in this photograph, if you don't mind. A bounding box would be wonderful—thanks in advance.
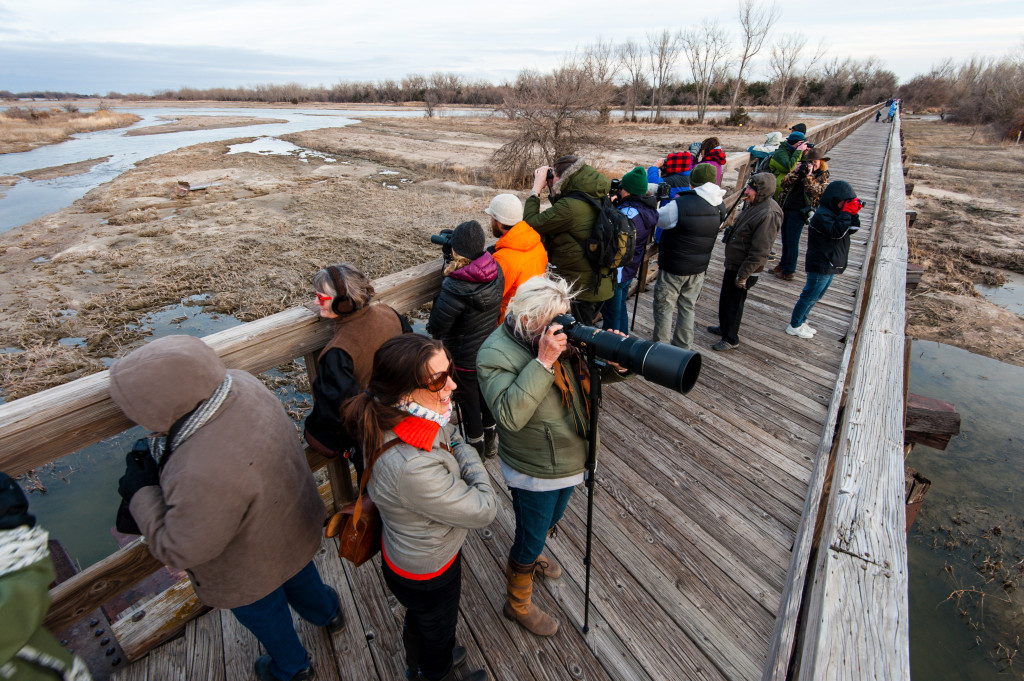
[493,57,608,186]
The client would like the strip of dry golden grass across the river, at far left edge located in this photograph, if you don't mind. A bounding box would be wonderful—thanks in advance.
[0,108,140,154]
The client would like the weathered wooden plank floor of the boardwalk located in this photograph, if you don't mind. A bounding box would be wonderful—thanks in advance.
[115,122,890,681]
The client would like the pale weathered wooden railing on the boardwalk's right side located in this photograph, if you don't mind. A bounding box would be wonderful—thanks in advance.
[762,108,910,681]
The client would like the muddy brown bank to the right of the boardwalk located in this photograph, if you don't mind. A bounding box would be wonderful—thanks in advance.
[904,120,1024,366]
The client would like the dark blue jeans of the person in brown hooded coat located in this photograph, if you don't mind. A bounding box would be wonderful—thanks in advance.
[231,560,340,681]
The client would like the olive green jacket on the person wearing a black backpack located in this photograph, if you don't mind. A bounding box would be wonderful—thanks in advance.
[522,159,613,302]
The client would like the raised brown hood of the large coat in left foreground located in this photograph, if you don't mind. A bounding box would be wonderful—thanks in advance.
[110,336,227,433]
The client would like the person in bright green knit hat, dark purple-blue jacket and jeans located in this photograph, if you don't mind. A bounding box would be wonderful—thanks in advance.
[601,166,657,334]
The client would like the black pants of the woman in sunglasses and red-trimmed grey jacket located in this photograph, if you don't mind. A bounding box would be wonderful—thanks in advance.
[381,554,462,681]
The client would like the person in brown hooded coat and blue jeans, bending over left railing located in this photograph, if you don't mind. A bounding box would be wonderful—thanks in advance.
[111,336,345,681]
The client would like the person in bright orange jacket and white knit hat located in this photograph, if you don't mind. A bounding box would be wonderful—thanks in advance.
[483,194,548,325]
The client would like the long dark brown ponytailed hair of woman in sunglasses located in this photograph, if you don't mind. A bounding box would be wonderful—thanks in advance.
[341,334,452,462]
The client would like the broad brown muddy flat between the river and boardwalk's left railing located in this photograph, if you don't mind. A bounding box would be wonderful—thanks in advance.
[0,111,790,399]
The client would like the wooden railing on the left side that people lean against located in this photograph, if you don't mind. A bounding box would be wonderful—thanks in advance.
[0,107,880,663]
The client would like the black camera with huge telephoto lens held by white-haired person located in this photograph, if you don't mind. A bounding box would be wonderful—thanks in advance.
[552,314,700,394]
